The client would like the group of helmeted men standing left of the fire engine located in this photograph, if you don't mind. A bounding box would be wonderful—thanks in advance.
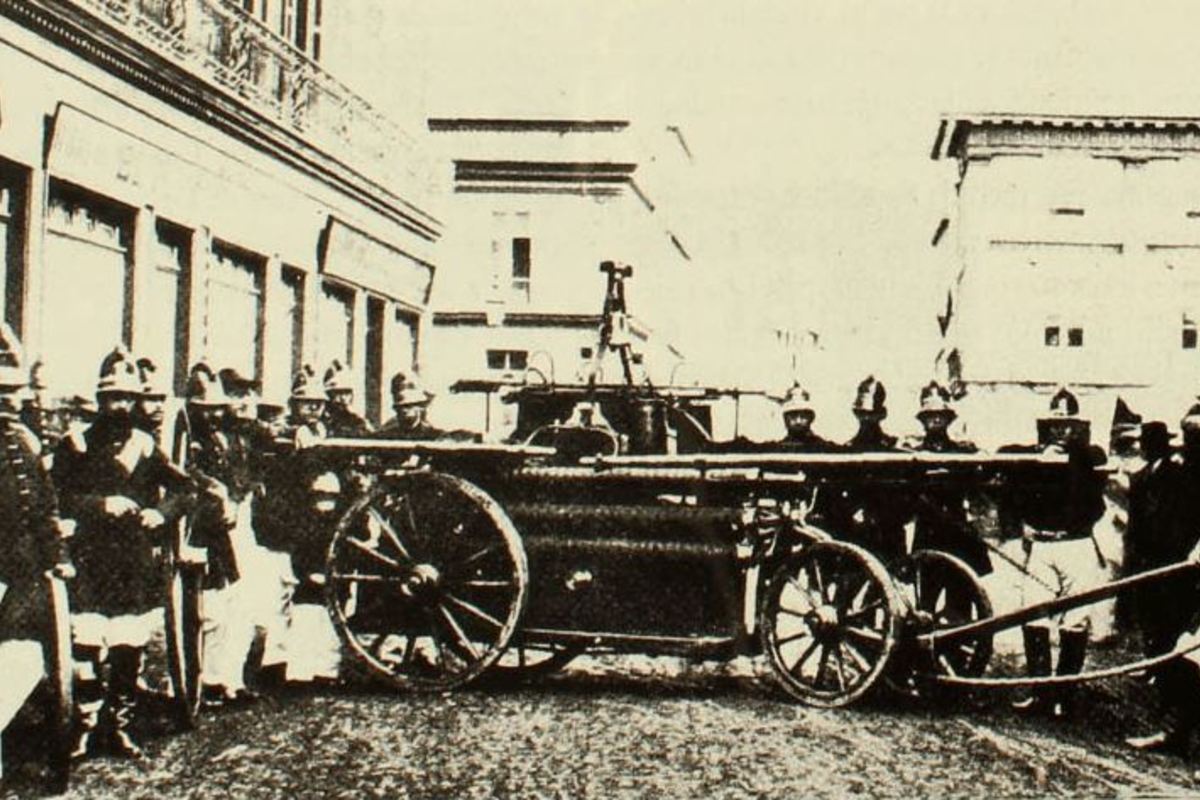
[0,324,446,758]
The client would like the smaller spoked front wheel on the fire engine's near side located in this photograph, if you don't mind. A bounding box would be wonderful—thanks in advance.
[758,542,901,708]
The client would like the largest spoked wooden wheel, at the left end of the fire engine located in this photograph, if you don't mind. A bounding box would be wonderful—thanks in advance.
[325,473,529,691]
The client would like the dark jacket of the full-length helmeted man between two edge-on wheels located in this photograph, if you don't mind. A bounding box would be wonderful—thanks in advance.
[52,417,190,616]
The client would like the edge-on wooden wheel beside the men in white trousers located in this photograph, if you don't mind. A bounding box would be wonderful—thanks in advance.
[163,411,204,728]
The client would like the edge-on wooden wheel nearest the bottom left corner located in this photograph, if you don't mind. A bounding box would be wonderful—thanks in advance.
[46,575,74,794]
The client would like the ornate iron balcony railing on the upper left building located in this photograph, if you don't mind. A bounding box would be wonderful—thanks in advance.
[68,0,413,187]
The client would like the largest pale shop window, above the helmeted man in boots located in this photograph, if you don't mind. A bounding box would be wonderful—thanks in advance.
[42,181,133,398]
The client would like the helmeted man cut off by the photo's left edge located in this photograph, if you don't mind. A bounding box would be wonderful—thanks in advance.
[0,321,73,642]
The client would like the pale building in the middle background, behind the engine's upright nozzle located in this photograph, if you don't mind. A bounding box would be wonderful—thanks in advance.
[424,119,690,438]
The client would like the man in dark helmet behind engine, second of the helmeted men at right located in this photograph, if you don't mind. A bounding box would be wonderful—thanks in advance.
[829,375,912,564]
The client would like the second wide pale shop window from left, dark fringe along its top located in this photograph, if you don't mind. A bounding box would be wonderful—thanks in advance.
[205,243,265,380]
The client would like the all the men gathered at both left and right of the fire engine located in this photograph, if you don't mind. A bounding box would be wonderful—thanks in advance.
[0,327,1200,757]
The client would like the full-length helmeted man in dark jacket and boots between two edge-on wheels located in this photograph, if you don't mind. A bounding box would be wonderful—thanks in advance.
[53,347,190,758]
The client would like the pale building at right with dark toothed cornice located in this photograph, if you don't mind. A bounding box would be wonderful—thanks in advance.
[932,115,1200,444]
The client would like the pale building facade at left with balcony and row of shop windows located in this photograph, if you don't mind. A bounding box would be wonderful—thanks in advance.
[0,0,440,429]
